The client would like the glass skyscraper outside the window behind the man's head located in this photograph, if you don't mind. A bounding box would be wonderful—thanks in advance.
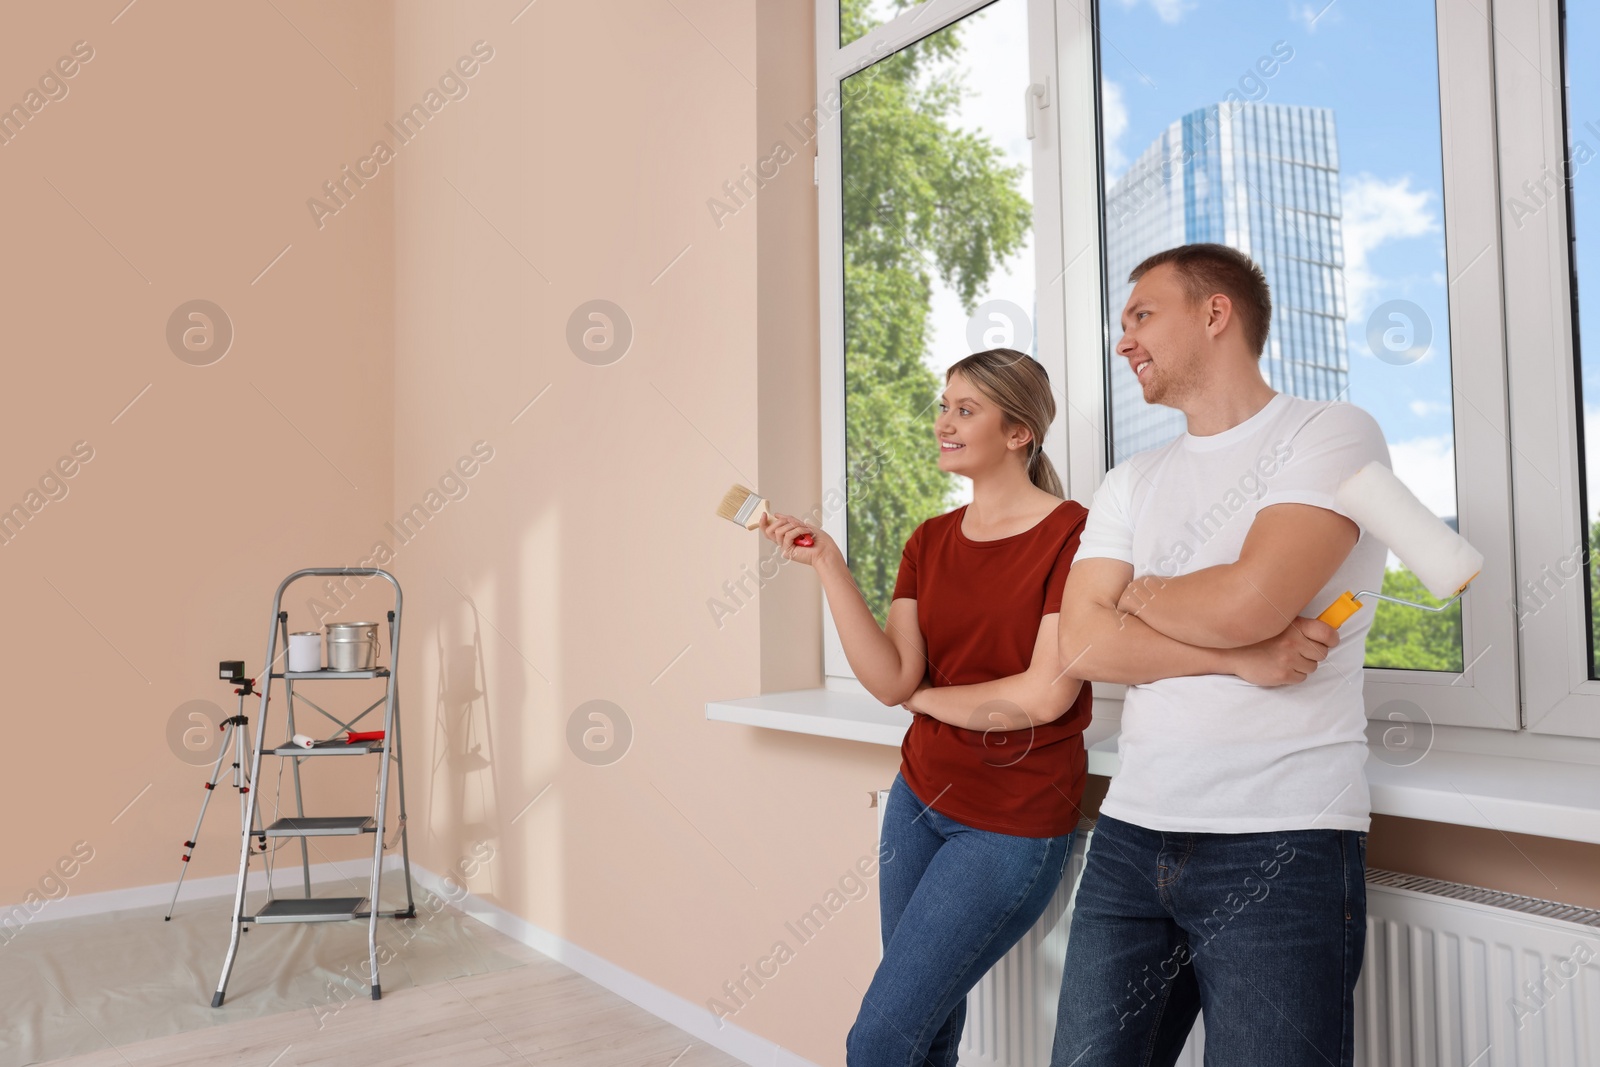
[1106,104,1350,464]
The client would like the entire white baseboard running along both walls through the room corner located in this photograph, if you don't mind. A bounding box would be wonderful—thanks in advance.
[0,856,816,1067]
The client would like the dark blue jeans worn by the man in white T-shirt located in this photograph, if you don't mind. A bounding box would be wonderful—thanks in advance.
[1050,816,1366,1067]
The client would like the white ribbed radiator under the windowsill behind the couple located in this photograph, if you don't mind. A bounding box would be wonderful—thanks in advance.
[878,806,1600,1067]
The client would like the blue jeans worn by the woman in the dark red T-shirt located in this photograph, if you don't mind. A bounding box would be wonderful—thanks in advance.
[845,774,1072,1067]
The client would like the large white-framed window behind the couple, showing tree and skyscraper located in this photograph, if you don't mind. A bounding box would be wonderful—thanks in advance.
[818,0,1523,728]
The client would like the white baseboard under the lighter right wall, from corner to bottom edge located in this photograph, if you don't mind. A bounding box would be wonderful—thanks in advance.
[400,864,816,1067]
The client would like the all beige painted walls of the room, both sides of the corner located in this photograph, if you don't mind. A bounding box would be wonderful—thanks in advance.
[9,0,1600,1064]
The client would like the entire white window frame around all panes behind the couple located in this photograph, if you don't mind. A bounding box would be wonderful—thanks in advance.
[816,0,1561,745]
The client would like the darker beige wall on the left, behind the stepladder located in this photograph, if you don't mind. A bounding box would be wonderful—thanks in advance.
[0,0,394,921]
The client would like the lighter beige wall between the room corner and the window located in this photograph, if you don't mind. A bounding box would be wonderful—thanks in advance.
[384,2,898,1064]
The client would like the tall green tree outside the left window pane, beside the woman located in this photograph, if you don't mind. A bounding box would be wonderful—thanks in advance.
[840,0,1032,624]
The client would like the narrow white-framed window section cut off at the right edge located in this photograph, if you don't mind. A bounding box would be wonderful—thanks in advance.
[1496,0,1600,737]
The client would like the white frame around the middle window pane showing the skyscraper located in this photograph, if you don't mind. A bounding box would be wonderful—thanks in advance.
[1058,0,1520,729]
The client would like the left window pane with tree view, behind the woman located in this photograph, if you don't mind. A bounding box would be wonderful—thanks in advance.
[819,0,1061,652]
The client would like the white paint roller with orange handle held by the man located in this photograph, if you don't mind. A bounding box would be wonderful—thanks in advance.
[1317,459,1483,629]
